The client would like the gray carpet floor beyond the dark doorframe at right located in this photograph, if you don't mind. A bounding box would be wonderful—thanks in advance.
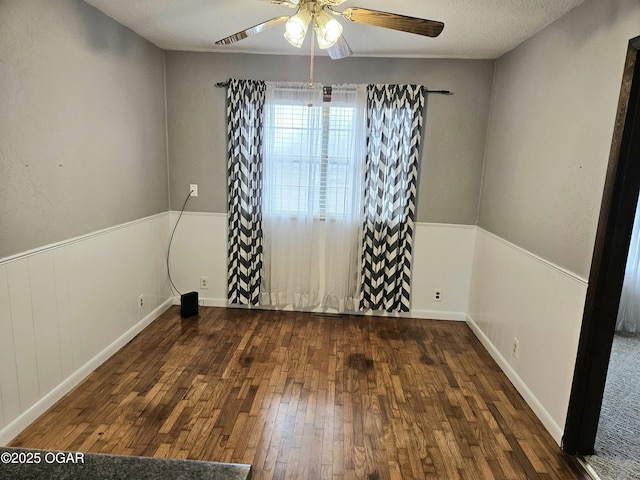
[586,334,640,480]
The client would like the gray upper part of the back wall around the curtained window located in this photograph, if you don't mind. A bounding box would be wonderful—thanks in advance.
[166,52,494,224]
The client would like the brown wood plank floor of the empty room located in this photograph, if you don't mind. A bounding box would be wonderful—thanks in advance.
[11,307,588,480]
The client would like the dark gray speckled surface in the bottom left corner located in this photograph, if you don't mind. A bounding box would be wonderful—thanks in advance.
[0,447,251,480]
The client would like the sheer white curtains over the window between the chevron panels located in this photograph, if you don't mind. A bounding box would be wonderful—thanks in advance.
[260,82,366,311]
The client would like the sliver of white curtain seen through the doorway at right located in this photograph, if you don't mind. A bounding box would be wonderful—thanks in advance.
[616,197,640,333]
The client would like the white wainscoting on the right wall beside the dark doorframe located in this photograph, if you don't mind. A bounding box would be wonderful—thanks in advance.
[468,228,587,444]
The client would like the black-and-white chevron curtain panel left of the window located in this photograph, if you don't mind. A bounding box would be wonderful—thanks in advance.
[227,79,266,305]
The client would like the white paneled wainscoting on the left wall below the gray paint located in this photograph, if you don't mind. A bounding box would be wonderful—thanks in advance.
[0,213,172,445]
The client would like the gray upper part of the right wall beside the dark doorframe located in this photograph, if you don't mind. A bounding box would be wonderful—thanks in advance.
[479,0,640,278]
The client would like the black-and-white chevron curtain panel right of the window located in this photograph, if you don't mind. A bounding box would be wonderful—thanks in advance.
[360,85,425,312]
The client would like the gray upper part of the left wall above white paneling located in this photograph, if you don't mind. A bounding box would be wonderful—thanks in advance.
[0,0,168,258]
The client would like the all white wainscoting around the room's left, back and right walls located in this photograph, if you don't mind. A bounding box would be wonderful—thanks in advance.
[0,212,587,445]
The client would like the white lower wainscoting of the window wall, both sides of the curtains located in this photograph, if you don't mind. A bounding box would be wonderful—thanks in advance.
[171,212,476,321]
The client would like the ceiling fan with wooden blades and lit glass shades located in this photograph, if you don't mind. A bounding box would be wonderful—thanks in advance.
[216,0,444,60]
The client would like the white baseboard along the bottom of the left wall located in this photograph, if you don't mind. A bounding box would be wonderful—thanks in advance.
[0,299,172,446]
